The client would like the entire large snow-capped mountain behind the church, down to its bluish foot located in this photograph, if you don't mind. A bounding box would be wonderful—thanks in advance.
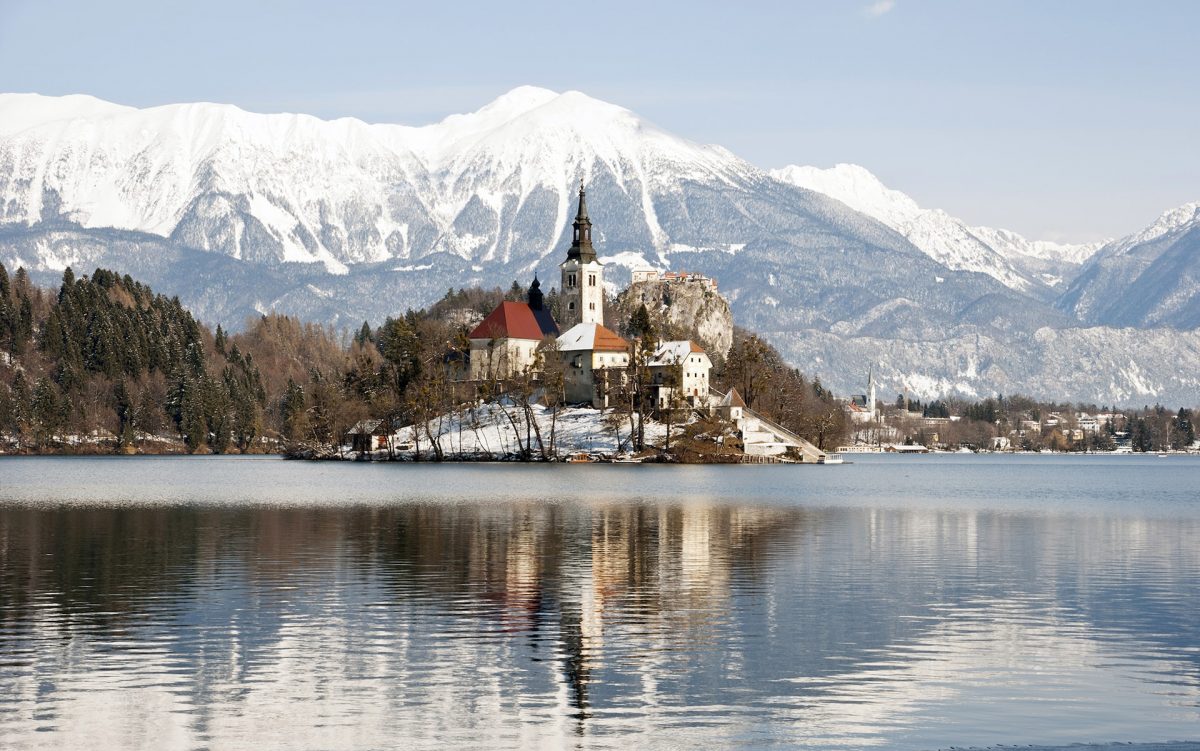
[0,88,1200,401]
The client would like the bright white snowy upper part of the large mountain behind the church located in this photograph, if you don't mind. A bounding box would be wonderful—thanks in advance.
[0,86,751,274]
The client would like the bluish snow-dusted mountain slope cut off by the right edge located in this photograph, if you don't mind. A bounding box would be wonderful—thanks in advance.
[1057,203,1200,329]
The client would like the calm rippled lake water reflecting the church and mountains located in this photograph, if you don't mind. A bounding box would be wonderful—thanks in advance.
[0,456,1200,750]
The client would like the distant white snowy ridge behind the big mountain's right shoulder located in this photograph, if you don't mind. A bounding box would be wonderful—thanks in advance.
[770,164,1103,298]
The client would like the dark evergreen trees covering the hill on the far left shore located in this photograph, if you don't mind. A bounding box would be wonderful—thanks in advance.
[0,268,266,451]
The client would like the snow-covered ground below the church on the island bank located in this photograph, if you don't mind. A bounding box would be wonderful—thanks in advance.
[344,402,666,459]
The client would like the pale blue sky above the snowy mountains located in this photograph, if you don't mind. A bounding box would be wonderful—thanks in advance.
[0,0,1200,241]
